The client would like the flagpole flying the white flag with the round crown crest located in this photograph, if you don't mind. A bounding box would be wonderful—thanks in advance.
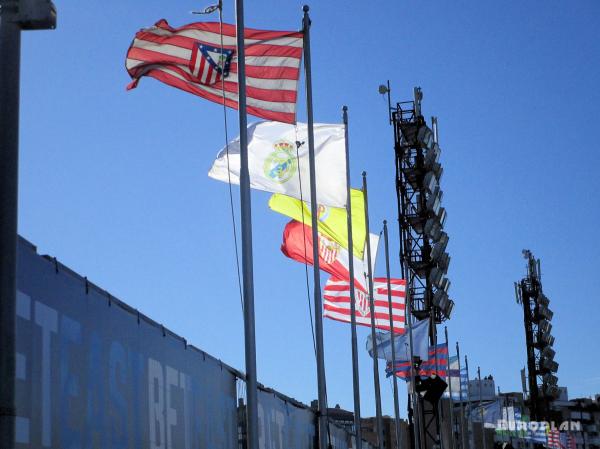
[342,106,362,449]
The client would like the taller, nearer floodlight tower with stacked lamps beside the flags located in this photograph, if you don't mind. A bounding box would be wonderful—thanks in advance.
[379,83,454,449]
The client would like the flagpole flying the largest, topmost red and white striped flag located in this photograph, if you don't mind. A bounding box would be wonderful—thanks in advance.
[302,5,330,449]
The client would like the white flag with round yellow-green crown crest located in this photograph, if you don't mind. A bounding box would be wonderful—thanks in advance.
[208,122,346,207]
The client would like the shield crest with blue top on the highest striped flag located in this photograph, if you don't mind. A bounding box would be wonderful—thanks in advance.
[189,42,233,86]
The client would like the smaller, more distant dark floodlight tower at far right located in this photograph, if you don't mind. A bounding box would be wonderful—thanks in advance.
[515,250,559,421]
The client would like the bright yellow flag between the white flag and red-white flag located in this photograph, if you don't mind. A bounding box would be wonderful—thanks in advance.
[269,189,367,259]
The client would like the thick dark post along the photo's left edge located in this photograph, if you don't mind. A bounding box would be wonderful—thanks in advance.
[0,1,21,448]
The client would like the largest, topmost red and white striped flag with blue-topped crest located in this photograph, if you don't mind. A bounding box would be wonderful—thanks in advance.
[126,19,303,123]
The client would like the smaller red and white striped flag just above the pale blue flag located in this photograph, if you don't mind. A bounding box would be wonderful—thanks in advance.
[323,277,406,334]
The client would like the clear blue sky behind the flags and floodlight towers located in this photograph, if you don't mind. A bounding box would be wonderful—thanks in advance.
[19,0,600,415]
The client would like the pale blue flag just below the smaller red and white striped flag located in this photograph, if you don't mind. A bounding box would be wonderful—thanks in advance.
[367,320,432,362]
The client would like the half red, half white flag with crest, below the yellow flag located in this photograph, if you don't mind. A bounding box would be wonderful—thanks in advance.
[281,220,379,292]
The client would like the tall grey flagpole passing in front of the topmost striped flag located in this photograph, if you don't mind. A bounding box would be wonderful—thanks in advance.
[235,0,258,449]
